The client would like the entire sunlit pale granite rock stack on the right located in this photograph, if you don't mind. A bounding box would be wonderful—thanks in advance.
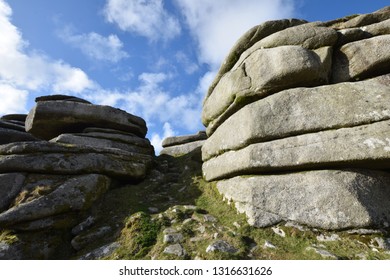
[202,7,390,229]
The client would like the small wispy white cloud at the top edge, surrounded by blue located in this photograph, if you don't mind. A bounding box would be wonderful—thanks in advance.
[104,0,181,41]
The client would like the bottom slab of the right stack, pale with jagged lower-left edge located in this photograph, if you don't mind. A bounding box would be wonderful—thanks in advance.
[217,170,390,229]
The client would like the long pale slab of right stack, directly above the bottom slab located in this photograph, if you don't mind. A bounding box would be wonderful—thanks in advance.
[203,121,390,181]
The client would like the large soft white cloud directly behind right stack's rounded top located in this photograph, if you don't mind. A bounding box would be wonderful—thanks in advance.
[175,0,294,70]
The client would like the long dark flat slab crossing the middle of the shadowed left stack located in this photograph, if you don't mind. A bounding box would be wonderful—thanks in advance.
[0,142,152,179]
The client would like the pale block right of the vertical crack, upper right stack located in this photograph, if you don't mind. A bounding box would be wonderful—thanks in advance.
[332,35,390,83]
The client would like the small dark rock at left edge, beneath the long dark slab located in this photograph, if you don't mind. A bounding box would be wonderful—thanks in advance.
[0,173,26,212]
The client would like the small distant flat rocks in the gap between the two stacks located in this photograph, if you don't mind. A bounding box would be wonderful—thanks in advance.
[160,131,207,156]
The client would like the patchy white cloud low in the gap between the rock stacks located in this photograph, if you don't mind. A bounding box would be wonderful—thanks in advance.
[84,73,202,135]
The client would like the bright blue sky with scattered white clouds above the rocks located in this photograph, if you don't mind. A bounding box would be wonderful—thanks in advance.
[0,0,389,152]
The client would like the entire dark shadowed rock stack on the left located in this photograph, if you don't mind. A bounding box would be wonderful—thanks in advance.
[0,95,154,259]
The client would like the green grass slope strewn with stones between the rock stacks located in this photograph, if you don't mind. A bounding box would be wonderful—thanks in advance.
[80,151,390,260]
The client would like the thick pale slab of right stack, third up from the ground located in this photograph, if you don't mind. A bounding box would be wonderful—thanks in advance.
[202,75,390,161]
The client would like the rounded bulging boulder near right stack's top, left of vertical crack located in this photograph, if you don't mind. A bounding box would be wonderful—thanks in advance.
[202,46,332,133]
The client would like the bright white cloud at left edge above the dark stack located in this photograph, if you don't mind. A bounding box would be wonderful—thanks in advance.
[0,0,97,113]
